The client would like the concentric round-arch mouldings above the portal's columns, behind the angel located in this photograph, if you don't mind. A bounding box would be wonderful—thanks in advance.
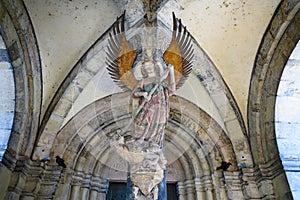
[51,93,237,198]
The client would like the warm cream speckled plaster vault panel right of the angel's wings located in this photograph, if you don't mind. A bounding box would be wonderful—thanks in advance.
[179,0,280,123]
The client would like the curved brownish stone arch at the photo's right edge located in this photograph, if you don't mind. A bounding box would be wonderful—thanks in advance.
[248,0,300,199]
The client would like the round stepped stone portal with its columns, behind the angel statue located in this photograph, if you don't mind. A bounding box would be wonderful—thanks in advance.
[46,93,239,199]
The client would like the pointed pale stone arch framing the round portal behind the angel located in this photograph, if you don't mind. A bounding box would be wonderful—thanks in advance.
[33,9,253,170]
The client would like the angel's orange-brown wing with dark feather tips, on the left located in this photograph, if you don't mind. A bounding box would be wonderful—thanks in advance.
[105,11,137,90]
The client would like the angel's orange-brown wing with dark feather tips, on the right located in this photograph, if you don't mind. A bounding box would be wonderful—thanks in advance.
[163,12,194,88]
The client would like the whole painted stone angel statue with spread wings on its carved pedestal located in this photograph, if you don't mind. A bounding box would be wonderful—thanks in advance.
[106,12,194,199]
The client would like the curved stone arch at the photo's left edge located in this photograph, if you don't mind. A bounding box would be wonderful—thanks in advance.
[0,0,42,166]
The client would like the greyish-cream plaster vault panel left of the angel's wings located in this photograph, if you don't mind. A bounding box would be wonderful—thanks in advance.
[24,0,121,115]
